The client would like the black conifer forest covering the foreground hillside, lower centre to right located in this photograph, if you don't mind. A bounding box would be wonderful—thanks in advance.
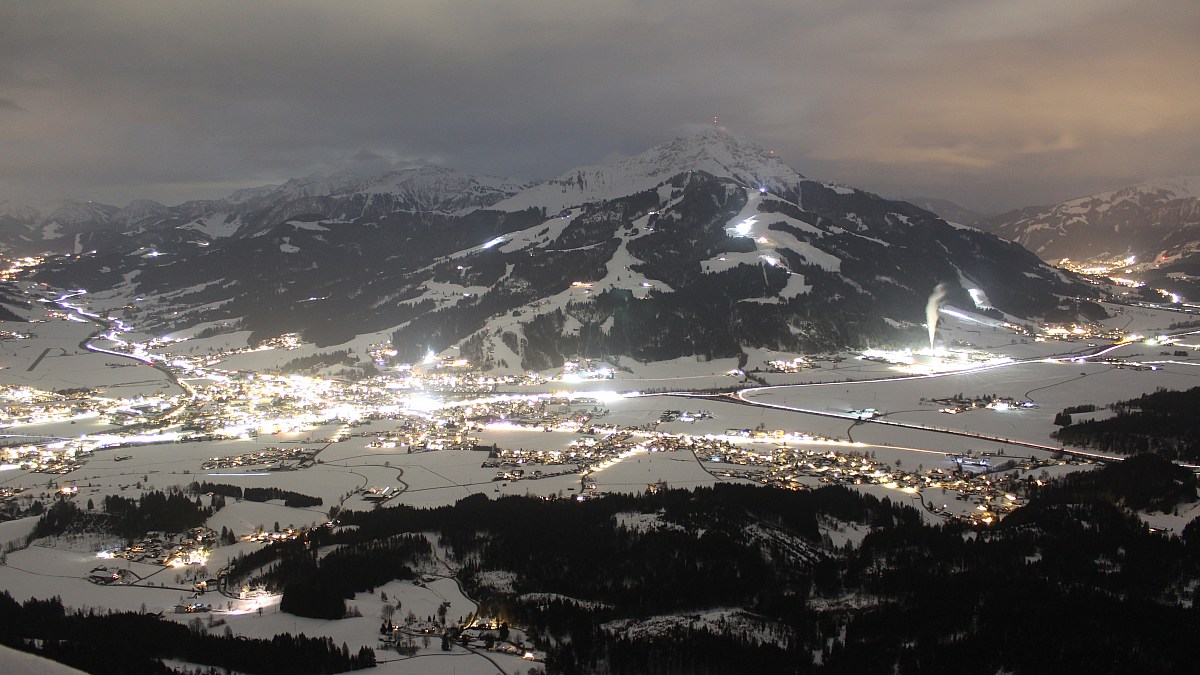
[218,475,1200,673]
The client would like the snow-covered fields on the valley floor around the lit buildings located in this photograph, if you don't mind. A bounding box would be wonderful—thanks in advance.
[0,282,1200,674]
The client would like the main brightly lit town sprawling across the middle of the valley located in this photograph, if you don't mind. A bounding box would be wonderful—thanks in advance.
[0,294,1099,524]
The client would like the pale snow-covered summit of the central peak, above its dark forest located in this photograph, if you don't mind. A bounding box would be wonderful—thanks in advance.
[496,127,804,213]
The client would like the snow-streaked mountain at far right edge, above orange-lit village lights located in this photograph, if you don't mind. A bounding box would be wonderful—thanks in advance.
[978,177,1200,262]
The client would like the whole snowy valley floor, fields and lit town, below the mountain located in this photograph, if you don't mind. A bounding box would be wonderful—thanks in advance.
[0,285,1200,673]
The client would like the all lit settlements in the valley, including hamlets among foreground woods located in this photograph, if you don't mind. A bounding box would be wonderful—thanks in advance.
[0,276,1180,662]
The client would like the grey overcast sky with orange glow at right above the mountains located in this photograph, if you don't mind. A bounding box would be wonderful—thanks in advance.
[0,0,1200,210]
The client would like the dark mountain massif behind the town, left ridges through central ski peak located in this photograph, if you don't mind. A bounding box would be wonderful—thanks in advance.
[18,129,1090,369]
